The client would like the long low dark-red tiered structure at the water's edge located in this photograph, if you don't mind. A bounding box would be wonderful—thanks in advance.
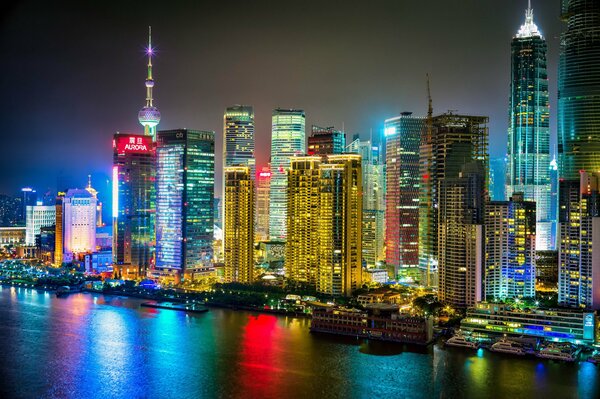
[310,303,433,345]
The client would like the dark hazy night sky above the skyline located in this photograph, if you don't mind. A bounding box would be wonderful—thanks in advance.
[0,0,562,201]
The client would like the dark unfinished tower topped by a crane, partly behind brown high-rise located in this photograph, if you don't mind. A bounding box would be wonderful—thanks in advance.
[418,112,489,286]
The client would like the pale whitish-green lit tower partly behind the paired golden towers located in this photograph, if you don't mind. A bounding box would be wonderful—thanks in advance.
[269,108,306,240]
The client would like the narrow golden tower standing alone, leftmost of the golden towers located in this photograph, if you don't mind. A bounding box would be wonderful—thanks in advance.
[223,166,254,283]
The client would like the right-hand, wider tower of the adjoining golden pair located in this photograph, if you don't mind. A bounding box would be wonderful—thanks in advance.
[316,154,362,296]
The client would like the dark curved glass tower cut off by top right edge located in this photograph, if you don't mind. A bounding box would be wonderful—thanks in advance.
[558,0,600,181]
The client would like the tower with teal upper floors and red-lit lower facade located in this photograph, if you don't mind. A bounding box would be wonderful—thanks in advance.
[384,112,426,280]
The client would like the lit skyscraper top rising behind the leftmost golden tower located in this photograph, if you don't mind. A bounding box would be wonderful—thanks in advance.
[223,105,255,179]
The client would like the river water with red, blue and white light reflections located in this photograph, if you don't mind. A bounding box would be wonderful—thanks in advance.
[0,287,600,399]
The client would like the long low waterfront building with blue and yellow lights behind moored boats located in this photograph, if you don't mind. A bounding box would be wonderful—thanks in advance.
[460,302,596,344]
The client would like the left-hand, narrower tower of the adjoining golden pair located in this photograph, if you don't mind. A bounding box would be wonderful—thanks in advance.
[285,156,321,286]
